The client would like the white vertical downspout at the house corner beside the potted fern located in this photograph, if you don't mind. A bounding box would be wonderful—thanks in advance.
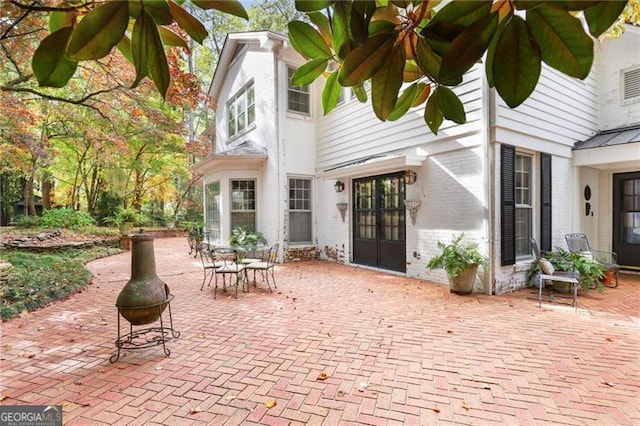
[480,72,496,295]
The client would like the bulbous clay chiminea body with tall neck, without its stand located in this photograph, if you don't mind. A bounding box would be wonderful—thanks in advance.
[116,230,170,325]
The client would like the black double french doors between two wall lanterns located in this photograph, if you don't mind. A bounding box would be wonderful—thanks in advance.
[353,173,407,272]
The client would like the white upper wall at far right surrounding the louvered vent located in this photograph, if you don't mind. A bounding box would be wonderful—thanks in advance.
[596,28,640,130]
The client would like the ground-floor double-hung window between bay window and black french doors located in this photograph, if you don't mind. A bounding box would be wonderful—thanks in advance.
[289,178,312,243]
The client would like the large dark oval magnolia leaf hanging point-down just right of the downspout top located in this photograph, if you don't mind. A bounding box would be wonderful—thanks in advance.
[488,16,542,108]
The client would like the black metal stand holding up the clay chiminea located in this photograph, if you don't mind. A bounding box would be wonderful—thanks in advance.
[109,294,180,364]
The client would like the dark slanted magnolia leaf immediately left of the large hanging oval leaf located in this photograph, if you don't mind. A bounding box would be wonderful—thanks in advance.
[440,13,498,81]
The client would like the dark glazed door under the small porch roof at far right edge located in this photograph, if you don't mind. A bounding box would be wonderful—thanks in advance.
[613,172,640,268]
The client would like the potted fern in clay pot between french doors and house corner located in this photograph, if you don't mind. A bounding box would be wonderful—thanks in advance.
[427,233,487,294]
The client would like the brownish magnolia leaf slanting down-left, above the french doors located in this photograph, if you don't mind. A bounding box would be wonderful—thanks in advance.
[338,34,396,86]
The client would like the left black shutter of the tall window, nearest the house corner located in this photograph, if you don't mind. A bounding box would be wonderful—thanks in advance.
[500,144,516,265]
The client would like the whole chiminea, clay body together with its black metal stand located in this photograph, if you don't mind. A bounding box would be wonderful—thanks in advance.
[110,230,180,363]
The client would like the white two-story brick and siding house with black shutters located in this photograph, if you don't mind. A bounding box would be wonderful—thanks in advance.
[194,27,640,294]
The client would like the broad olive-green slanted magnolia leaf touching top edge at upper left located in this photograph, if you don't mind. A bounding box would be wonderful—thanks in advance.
[67,1,129,61]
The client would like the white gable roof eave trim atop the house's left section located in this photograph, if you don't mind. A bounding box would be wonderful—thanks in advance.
[209,31,289,99]
